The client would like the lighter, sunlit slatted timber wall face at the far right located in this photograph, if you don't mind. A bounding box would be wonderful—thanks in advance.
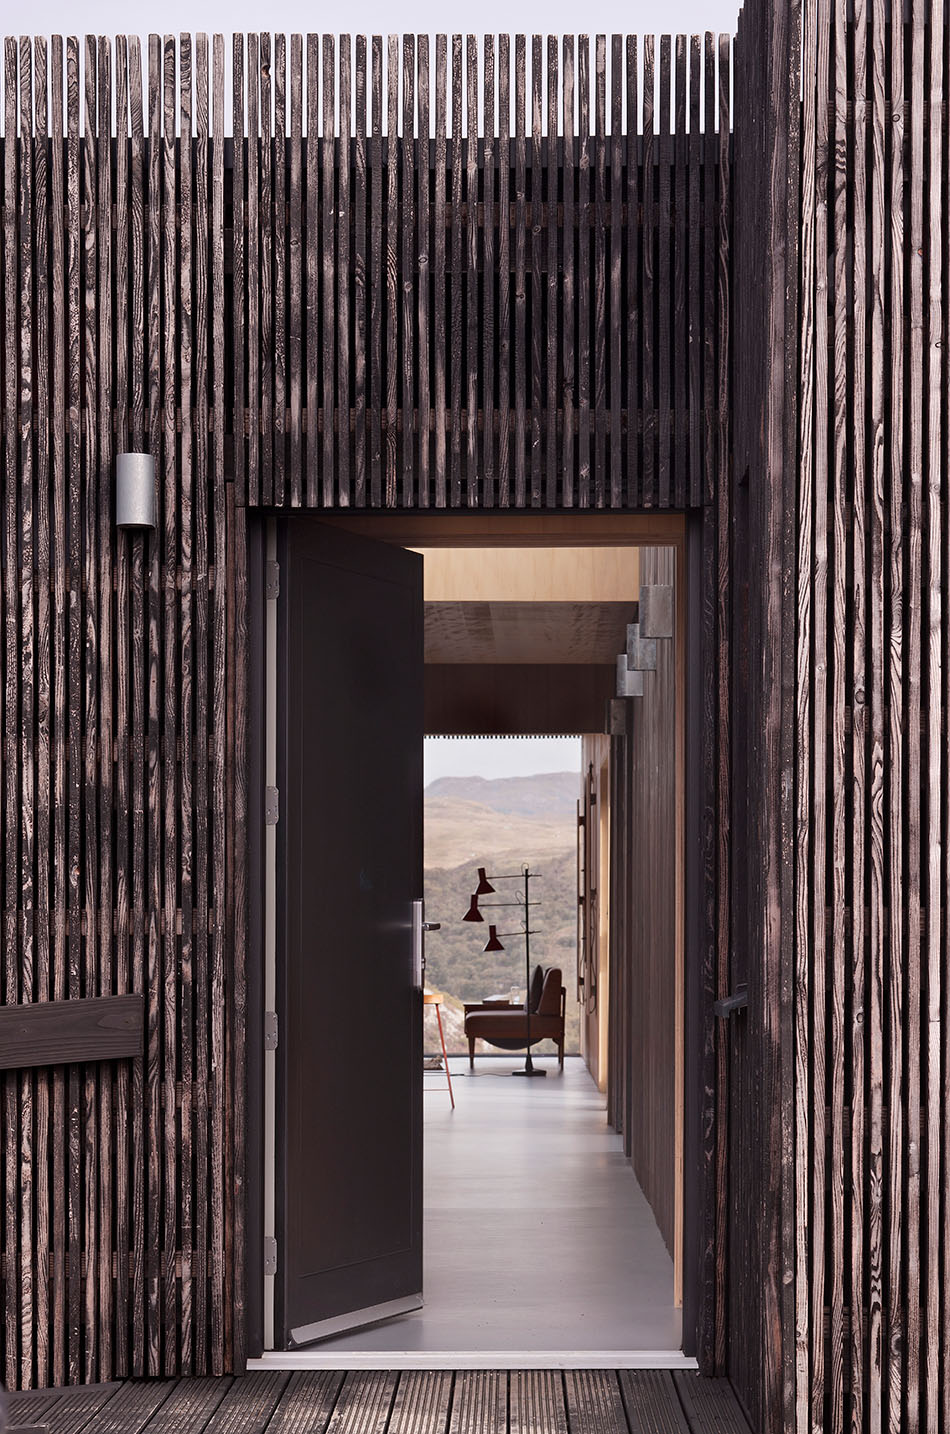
[786,0,950,1434]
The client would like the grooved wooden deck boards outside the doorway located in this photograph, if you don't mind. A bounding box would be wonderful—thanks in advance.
[10,1369,749,1434]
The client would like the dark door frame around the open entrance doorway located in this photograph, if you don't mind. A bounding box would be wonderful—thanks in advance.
[244,509,715,1357]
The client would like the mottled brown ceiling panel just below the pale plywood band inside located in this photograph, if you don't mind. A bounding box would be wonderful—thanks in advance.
[425,602,636,665]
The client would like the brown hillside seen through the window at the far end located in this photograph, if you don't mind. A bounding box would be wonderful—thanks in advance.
[425,773,580,1051]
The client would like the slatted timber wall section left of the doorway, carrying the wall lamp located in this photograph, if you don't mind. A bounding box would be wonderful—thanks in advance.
[0,36,240,1385]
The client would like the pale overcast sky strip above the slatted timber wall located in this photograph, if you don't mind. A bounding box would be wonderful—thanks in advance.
[16,0,738,45]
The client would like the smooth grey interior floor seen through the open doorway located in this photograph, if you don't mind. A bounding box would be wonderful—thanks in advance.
[308,1057,682,1358]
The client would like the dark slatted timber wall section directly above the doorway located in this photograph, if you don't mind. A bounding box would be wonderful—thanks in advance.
[232,36,729,509]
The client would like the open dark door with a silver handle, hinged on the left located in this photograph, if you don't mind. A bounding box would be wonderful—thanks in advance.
[276,515,422,1348]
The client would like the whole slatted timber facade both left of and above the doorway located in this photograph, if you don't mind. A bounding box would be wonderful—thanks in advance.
[0,34,730,1385]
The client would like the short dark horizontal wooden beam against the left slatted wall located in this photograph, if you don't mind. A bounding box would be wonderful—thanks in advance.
[0,995,145,1071]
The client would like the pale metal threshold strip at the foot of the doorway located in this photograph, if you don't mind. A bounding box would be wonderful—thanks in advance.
[247,1349,699,1369]
